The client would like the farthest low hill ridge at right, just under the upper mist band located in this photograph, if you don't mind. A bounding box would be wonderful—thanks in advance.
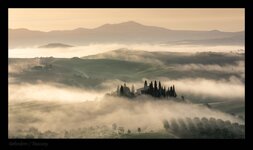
[81,49,244,65]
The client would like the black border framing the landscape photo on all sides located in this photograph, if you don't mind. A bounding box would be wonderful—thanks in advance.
[0,0,253,149]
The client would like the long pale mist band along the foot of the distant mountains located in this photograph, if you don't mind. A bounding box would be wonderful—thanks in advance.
[9,43,244,58]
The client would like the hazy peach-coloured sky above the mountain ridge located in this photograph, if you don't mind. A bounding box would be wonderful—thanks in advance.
[9,8,244,31]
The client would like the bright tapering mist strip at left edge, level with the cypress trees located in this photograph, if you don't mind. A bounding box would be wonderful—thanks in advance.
[9,83,103,103]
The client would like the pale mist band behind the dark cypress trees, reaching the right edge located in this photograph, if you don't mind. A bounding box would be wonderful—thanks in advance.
[100,76,245,101]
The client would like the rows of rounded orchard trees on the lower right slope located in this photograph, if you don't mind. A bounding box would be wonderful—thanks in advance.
[163,117,245,139]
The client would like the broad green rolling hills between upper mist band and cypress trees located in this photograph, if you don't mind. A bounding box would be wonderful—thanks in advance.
[9,50,244,88]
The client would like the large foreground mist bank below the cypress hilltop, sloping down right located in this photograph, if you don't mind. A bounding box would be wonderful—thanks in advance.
[9,84,244,138]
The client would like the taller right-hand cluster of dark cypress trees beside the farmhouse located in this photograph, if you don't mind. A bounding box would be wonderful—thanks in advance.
[143,81,177,97]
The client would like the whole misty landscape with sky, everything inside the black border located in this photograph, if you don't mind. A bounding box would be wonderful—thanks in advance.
[8,8,245,139]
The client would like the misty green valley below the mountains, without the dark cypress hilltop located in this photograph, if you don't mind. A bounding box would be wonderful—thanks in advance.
[8,47,245,138]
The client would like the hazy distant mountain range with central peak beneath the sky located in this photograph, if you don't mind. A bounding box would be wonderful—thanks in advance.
[9,21,245,48]
